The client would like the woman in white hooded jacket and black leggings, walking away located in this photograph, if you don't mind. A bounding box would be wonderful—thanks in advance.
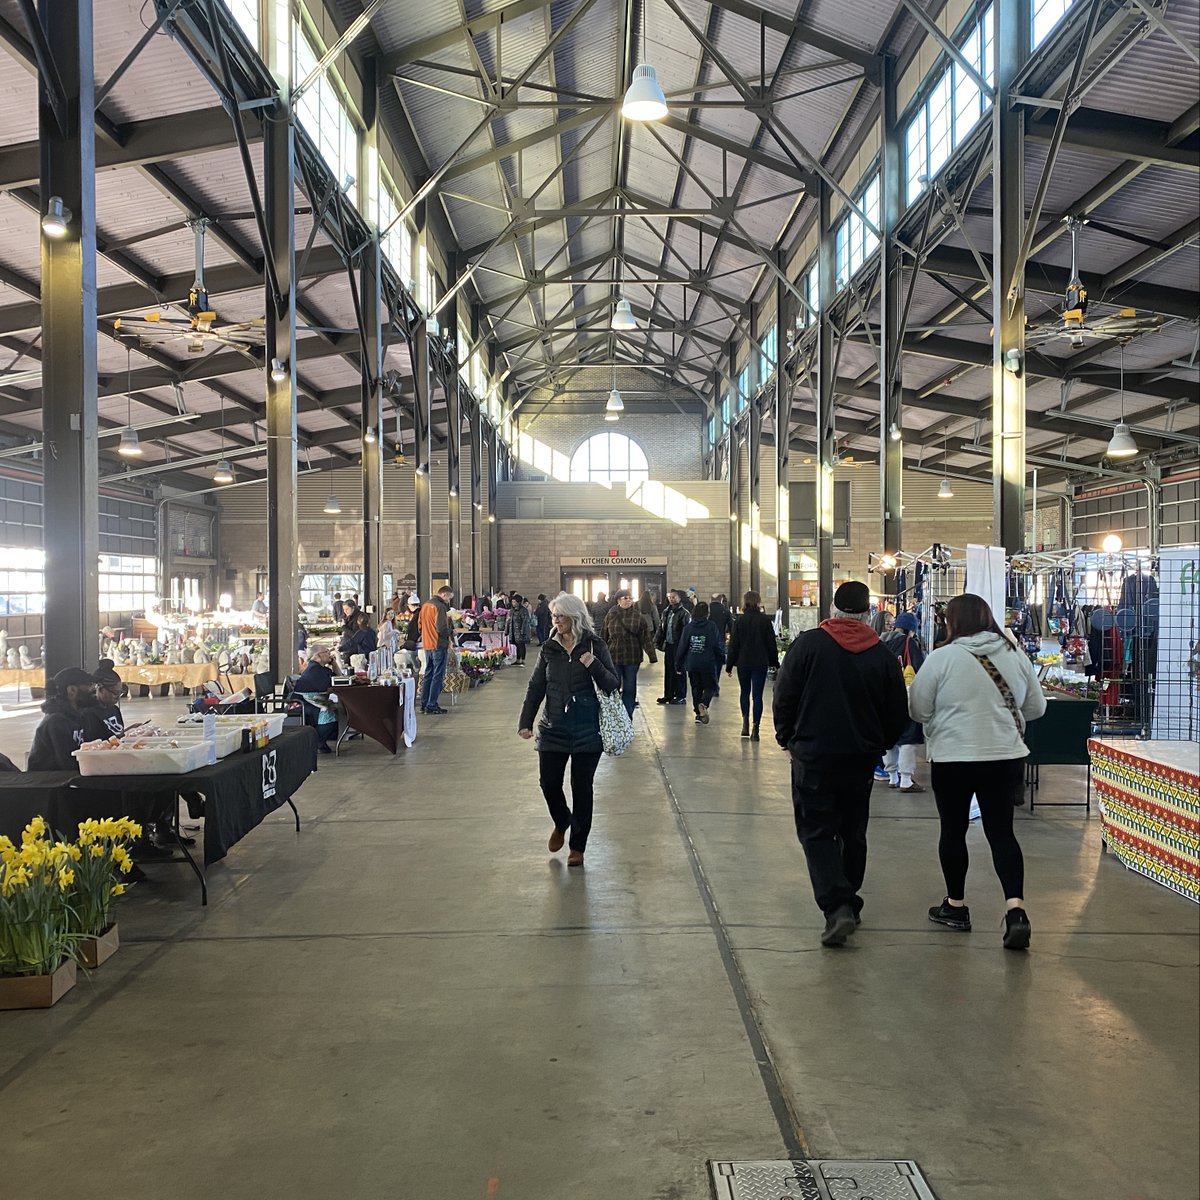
[908,595,1046,950]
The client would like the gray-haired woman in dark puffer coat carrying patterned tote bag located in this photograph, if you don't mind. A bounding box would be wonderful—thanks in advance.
[517,592,620,866]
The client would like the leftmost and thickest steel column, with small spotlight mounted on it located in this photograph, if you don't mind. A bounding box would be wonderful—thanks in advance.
[37,0,100,678]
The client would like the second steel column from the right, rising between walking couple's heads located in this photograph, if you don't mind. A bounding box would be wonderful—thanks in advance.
[880,55,904,576]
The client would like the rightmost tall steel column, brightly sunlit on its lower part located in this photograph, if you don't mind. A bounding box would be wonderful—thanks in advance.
[991,0,1030,553]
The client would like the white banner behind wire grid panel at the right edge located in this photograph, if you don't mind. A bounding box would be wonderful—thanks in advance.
[1148,546,1200,742]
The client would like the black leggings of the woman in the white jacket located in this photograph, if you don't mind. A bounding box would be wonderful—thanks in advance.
[930,758,1025,900]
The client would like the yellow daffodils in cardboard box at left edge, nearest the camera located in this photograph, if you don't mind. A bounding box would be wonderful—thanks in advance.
[0,817,82,1009]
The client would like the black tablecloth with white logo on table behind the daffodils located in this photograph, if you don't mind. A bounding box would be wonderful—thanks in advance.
[48,728,317,866]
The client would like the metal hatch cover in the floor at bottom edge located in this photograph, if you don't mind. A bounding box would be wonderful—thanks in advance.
[709,1158,936,1200]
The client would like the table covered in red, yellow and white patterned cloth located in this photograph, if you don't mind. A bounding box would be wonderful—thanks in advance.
[1087,738,1200,902]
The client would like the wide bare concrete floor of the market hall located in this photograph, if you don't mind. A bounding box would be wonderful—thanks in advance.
[0,668,1200,1200]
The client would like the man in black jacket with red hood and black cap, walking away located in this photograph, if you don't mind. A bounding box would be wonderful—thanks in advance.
[774,582,908,946]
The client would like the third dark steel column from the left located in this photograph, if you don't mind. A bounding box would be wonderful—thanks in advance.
[359,233,384,614]
